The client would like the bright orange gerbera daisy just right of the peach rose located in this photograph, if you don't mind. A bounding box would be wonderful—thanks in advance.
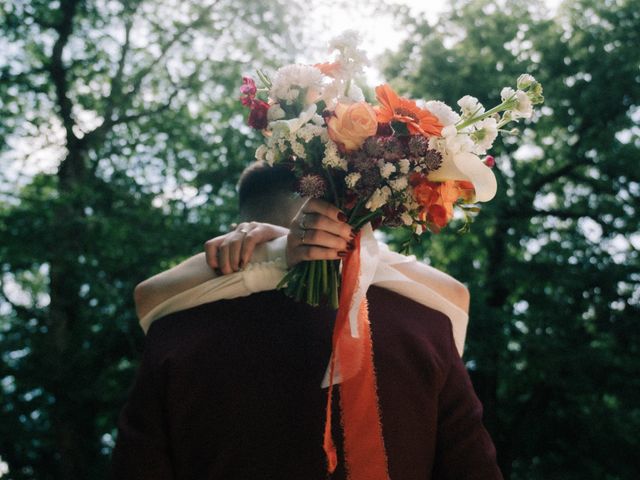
[376,84,442,137]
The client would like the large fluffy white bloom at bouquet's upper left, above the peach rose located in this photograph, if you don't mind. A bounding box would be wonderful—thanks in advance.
[269,64,323,103]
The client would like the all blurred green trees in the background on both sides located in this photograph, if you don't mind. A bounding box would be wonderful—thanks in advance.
[0,0,640,480]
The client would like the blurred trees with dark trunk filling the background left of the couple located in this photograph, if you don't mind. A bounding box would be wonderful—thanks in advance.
[0,0,301,479]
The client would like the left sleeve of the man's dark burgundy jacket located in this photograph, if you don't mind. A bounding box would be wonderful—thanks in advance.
[111,329,174,480]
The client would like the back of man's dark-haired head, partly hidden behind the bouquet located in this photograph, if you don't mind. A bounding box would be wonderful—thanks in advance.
[238,161,303,226]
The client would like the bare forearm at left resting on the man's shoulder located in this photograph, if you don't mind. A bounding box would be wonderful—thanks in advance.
[134,253,217,319]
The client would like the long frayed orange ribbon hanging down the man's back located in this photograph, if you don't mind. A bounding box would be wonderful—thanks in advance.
[323,234,389,480]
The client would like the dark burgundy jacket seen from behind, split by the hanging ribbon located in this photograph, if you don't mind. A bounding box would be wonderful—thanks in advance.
[112,287,502,480]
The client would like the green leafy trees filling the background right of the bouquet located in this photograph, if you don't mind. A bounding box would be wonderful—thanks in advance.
[386,0,640,480]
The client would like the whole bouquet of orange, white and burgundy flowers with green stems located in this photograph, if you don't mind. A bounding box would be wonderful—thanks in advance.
[241,32,543,308]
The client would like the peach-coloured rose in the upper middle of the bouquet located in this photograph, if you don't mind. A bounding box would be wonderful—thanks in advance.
[327,102,378,152]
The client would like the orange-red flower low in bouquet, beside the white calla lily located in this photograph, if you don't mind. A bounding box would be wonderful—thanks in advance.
[413,180,468,229]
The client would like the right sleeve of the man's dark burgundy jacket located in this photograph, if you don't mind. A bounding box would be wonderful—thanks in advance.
[433,330,503,480]
